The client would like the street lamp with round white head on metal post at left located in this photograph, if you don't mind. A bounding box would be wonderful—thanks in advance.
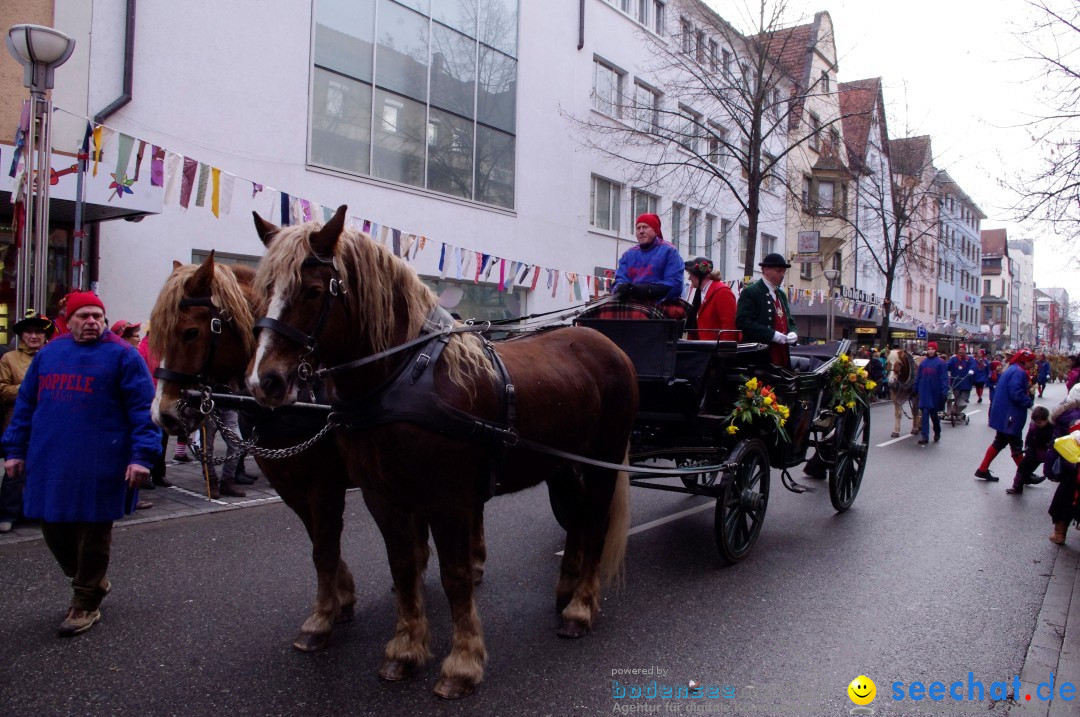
[6,25,75,316]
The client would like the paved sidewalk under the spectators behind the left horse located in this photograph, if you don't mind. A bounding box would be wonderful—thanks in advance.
[0,436,281,547]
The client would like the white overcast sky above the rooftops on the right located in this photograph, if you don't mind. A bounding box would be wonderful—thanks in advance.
[712,0,1080,297]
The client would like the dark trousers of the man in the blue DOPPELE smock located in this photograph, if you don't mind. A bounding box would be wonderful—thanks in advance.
[41,520,112,611]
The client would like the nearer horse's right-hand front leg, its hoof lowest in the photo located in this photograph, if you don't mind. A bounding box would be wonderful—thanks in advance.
[431,505,487,700]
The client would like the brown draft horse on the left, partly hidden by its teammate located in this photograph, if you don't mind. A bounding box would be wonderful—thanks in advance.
[150,253,356,651]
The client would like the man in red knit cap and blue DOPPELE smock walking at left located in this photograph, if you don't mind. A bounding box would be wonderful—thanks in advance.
[3,292,161,637]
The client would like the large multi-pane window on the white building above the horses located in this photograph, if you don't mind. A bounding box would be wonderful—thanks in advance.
[309,0,518,208]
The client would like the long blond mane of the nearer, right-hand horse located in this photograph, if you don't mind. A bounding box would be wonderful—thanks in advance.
[255,221,496,388]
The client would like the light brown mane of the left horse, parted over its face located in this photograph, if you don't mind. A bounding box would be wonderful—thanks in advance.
[150,262,255,355]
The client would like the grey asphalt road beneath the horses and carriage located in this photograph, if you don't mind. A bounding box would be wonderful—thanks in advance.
[0,384,1080,715]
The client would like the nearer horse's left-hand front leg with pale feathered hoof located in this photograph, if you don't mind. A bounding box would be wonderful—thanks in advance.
[364,490,429,681]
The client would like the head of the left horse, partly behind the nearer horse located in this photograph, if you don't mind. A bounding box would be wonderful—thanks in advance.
[150,252,255,434]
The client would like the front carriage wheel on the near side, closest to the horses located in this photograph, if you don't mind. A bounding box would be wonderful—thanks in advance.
[714,438,769,564]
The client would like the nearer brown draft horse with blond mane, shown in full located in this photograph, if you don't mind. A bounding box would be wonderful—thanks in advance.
[247,206,637,698]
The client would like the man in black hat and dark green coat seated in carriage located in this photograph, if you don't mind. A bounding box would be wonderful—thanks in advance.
[735,254,799,368]
